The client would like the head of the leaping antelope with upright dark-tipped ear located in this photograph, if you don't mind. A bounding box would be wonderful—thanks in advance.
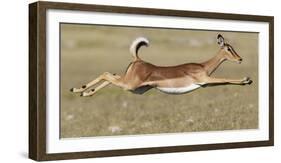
[217,34,242,64]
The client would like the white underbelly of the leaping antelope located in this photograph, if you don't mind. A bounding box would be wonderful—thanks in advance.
[156,84,202,94]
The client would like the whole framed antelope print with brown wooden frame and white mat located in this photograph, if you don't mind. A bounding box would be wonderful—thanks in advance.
[29,2,274,160]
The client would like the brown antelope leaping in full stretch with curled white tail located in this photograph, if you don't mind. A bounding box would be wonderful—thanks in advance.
[71,34,252,96]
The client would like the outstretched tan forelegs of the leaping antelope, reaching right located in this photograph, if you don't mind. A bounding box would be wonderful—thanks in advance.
[201,77,253,85]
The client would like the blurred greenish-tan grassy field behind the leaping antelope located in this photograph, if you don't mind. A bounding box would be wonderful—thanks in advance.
[61,24,258,138]
